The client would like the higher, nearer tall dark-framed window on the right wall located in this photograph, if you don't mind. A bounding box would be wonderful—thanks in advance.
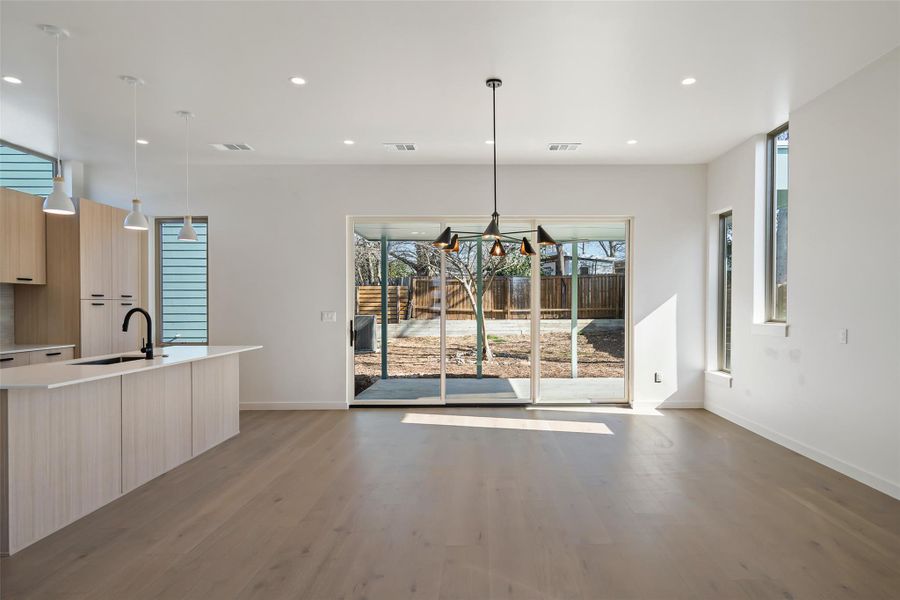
[766,123,790,322]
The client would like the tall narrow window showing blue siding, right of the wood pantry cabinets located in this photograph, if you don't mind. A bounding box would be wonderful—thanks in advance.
[156,217,209,344]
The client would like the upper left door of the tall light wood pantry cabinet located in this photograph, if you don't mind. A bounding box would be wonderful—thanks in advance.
[78,198,114,300]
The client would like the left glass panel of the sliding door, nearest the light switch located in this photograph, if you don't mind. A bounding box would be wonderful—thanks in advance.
[353,222,441,404]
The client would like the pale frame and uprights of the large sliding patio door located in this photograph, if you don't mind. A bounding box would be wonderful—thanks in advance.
[344,215,634,407]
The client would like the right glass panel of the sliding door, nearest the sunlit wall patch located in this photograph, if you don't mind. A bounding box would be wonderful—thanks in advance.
[540,223,628,403]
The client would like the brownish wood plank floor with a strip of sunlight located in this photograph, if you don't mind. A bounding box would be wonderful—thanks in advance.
[2,408,900,600]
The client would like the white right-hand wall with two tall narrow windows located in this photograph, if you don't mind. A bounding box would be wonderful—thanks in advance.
[706,45,900,497]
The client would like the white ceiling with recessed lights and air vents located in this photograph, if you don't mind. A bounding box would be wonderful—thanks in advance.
[0,1,900,170]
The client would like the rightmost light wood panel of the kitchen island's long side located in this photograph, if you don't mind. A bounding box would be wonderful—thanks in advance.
[191,354,240,456]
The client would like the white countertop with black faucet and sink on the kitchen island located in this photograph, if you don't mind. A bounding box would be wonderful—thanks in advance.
[0,346,262,390]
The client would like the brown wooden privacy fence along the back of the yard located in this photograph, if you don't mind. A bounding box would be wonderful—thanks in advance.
[356,274,625,323]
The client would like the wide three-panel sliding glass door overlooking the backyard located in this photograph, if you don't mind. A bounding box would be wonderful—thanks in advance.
[351,219,628,404]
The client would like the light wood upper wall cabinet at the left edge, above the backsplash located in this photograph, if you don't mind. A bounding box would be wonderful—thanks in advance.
[0,188,47,284]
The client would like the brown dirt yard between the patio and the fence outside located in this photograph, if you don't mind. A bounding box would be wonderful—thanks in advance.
[355,329,625,394]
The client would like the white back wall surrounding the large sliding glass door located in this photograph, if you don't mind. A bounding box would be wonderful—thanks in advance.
[88,166,706,407]
